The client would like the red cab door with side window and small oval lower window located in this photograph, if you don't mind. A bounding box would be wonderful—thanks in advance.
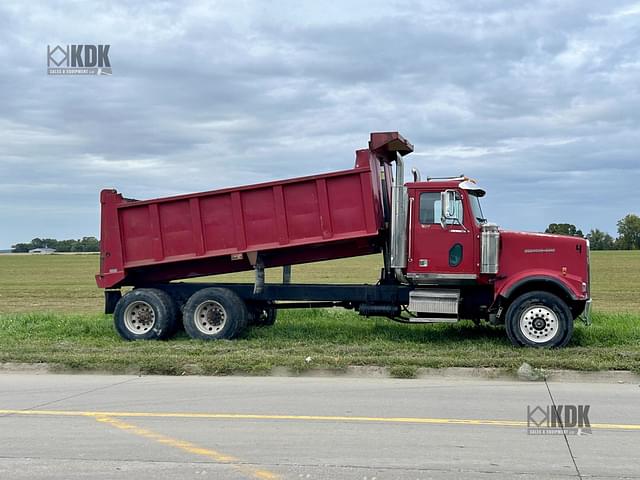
[407,189,478,281]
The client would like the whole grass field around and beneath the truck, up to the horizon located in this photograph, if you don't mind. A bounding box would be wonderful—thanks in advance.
[0,251,640,376]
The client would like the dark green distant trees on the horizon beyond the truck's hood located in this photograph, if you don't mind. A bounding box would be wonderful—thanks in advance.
[545,213,640,250]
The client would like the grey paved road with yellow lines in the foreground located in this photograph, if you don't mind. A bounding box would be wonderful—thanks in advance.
[0,374,640,480]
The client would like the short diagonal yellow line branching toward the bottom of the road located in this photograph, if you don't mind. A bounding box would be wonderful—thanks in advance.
[91,414,278,480]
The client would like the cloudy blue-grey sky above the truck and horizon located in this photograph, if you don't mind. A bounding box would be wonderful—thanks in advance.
[0,0,640,249]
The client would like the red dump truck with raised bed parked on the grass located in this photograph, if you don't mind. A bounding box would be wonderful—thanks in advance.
[96,132,591,347]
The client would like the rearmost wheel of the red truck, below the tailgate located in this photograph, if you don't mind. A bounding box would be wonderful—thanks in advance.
[113,288,177,340]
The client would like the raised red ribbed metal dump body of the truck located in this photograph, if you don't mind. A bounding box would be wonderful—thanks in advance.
[96,134,410,288]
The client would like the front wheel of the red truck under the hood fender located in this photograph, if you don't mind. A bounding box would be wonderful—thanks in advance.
[505,291,573,347]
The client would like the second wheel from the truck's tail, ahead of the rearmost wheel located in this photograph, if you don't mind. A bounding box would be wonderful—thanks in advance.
[182,288,249,340]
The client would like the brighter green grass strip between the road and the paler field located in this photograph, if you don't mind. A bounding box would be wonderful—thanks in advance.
[0,310,640,377]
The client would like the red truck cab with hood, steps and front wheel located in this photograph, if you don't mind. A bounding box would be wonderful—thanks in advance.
[406,175,591,346]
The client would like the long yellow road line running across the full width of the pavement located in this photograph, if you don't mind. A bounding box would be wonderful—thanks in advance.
[0,410,640,430]
